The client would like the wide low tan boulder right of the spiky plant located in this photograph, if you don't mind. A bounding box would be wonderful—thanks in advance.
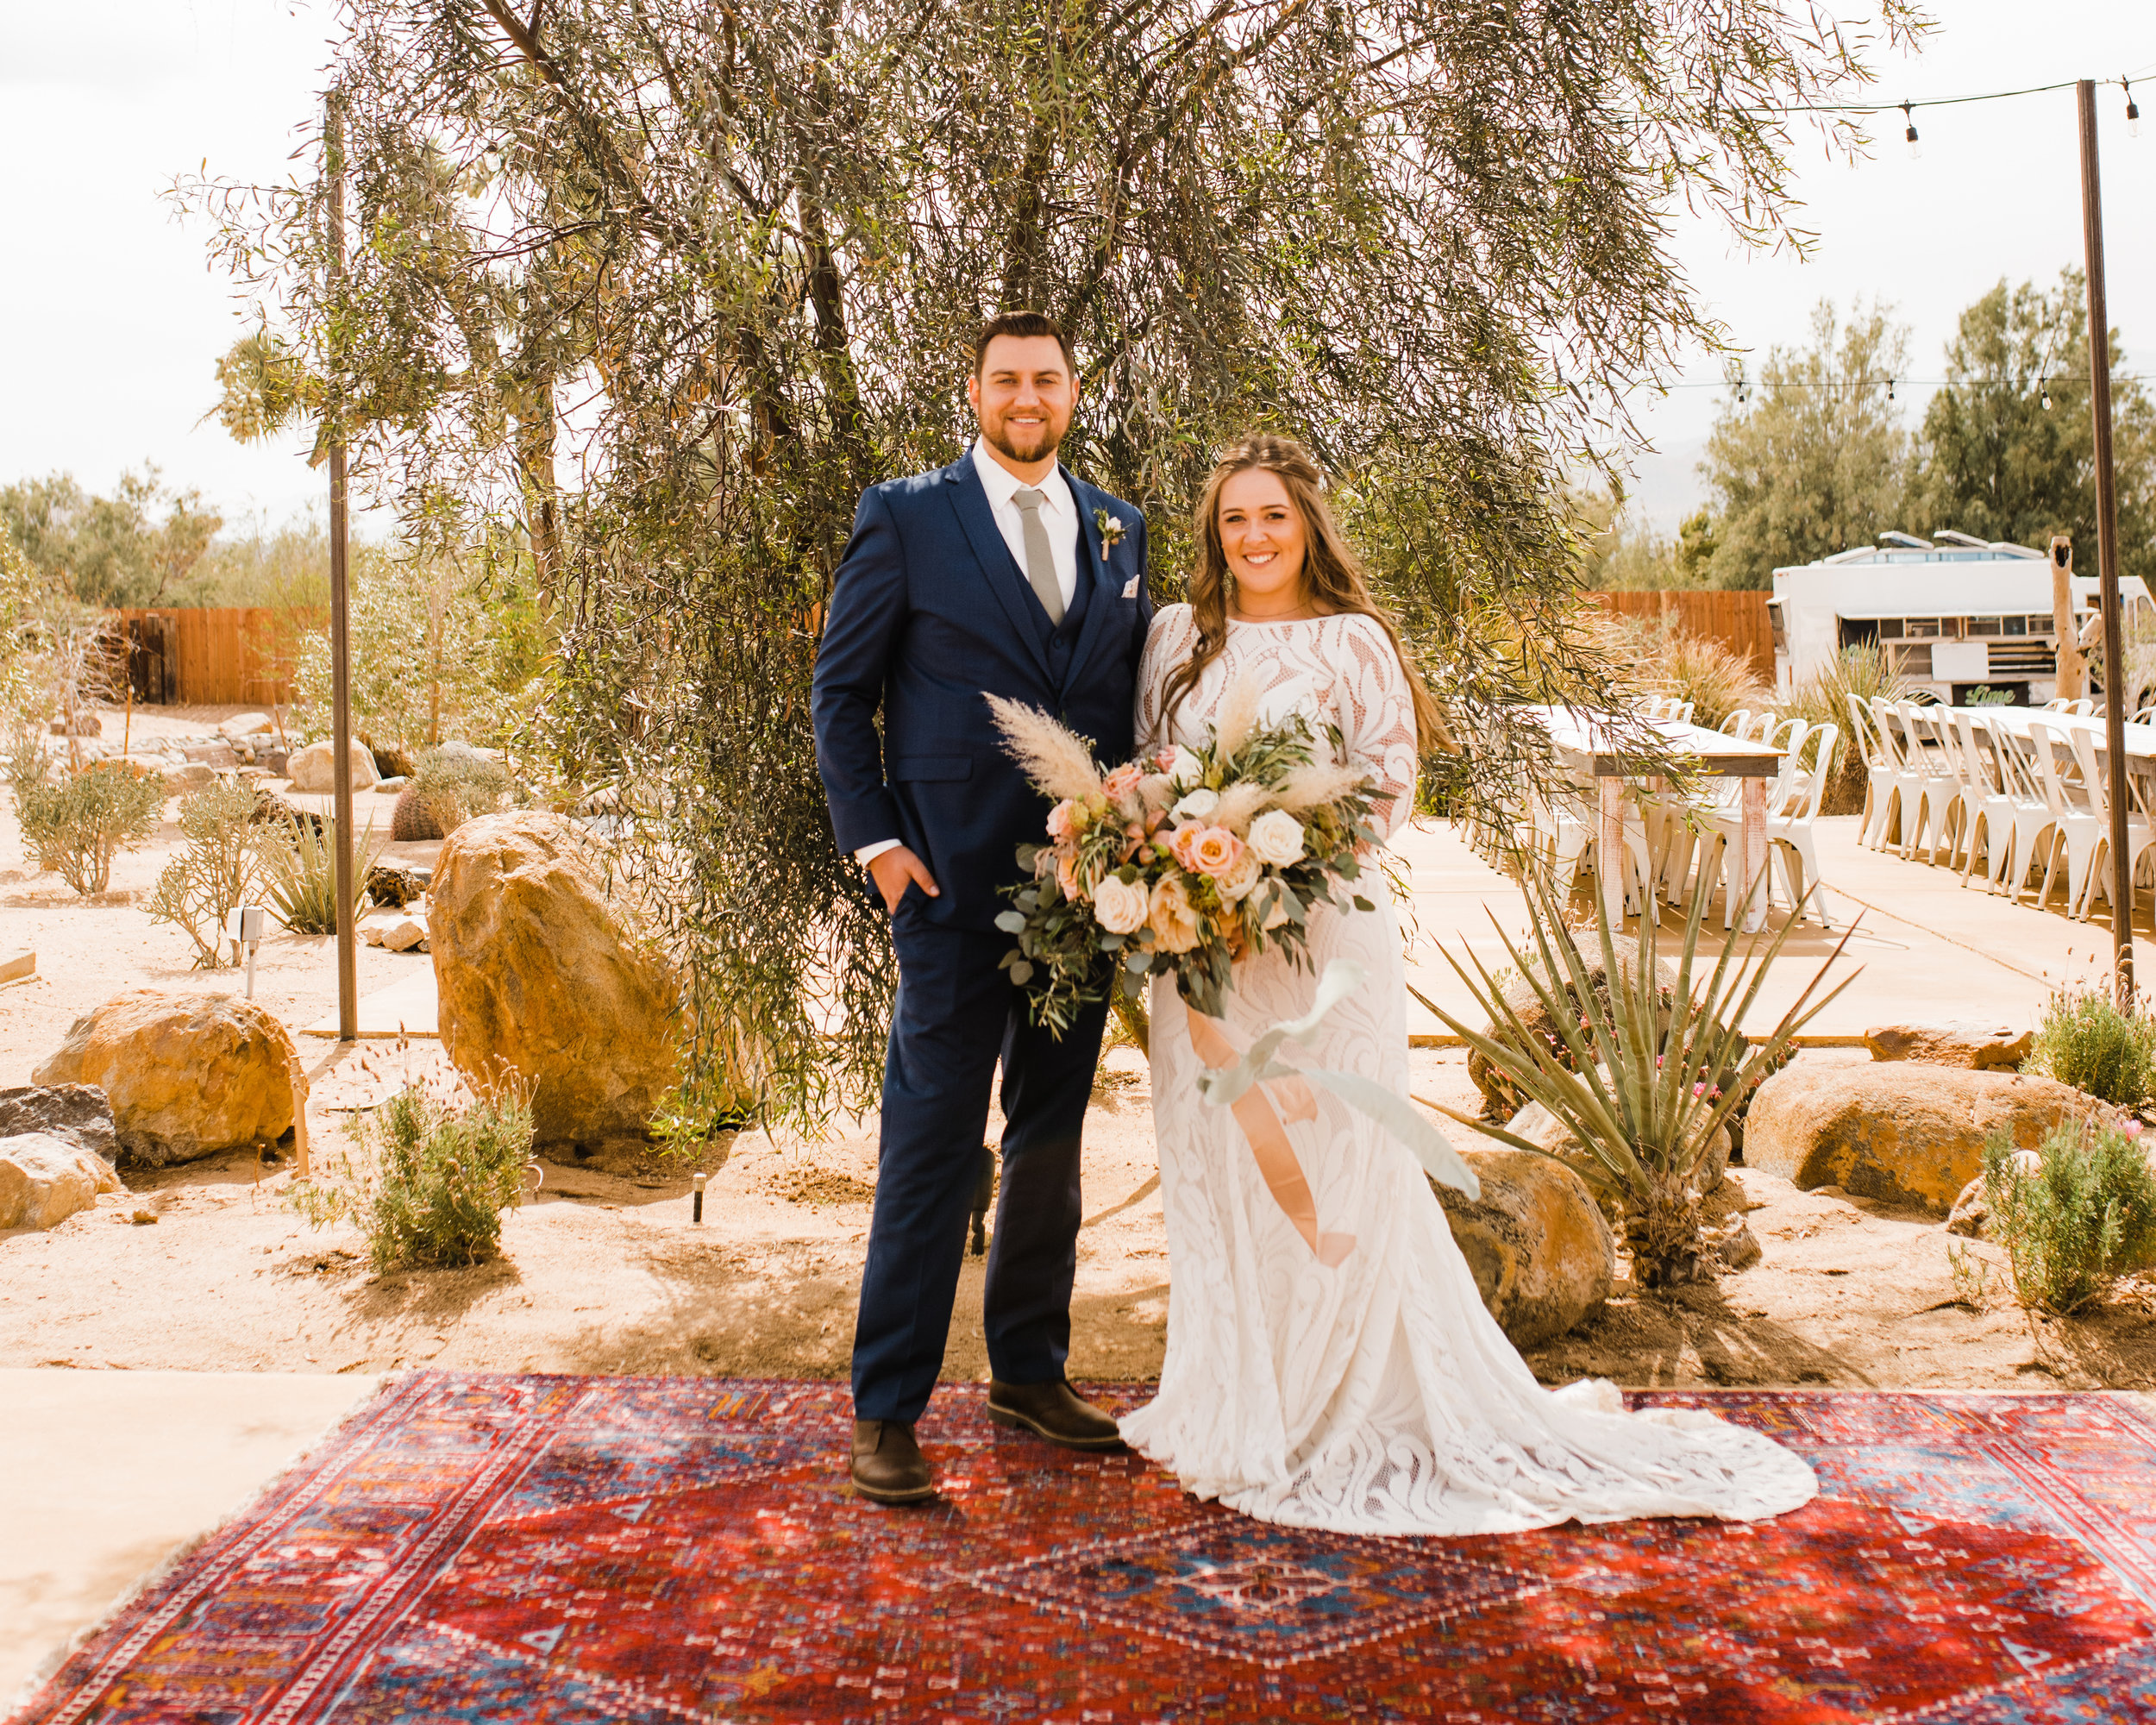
[1745,1061,2111,1216]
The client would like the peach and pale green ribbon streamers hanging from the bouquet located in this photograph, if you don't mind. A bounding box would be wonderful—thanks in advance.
[1190,957,1482,1264]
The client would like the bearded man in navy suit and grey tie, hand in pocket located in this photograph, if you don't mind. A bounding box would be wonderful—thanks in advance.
[813,313,1154,1503]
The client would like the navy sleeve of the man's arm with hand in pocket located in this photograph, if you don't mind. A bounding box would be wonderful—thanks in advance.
[809,487,908,852]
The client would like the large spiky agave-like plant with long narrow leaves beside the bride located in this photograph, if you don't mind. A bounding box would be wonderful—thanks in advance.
[1410,871,1857,1288]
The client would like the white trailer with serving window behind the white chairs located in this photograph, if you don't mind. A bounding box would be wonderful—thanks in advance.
[1768,533,2150,707]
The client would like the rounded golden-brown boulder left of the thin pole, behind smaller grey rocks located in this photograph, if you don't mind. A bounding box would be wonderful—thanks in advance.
[30,988,306,1167]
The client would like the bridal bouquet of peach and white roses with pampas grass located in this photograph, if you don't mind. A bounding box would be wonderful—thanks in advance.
[987,680,1376,1035]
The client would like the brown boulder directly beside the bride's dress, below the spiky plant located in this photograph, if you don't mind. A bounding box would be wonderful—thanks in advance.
[1432,1150,1617,1348]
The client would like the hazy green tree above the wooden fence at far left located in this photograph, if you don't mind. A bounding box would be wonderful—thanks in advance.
[0,466,224,606]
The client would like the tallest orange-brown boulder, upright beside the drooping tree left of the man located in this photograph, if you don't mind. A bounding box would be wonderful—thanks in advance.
[427,811,680,1145]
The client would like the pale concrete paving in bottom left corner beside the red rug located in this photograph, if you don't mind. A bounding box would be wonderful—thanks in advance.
[0,1370,379,1712]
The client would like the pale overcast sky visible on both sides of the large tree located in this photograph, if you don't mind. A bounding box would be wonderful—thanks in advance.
[0,0,2156,539]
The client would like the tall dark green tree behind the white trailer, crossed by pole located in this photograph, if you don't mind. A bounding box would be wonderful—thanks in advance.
[1910,270,2156,578]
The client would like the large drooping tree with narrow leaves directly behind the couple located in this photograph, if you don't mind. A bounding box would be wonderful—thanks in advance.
[184,0,1921,1115]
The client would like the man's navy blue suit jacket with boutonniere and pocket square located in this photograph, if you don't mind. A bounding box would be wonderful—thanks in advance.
[811,451,1154,930]
